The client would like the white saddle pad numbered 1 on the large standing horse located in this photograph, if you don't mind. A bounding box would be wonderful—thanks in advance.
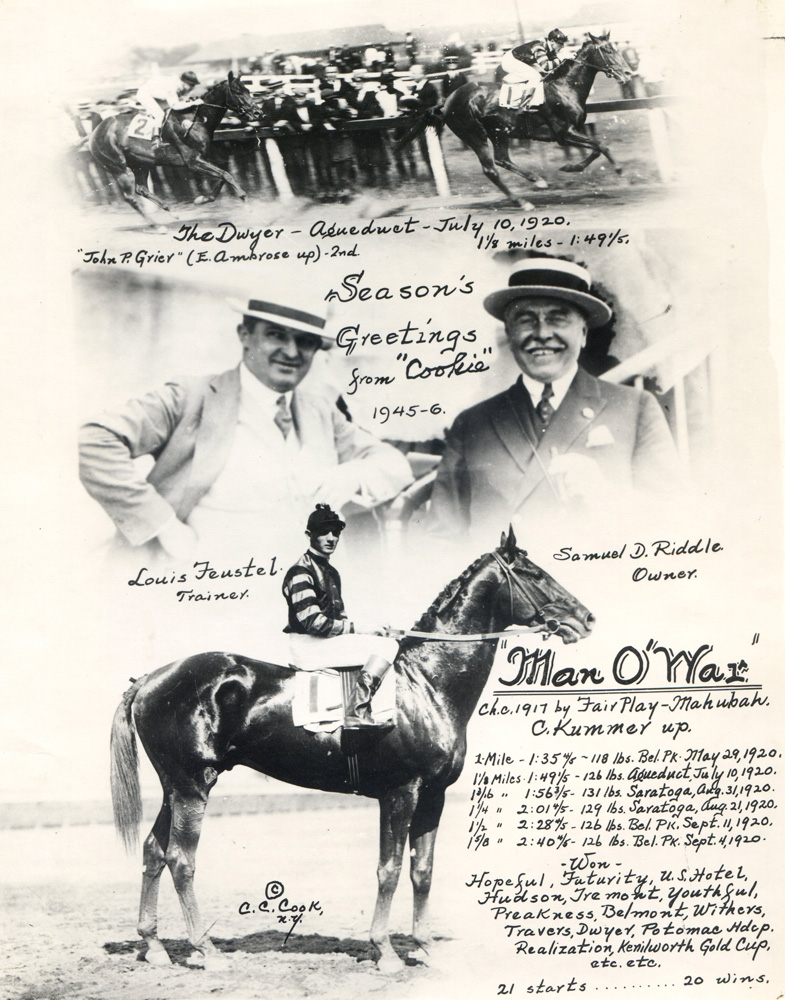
[292,670,395,733]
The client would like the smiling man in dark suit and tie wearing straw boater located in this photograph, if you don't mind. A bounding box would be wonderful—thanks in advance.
[429,257,678,535]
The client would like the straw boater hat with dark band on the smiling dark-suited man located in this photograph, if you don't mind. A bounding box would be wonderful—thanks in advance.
[483,257,613,329]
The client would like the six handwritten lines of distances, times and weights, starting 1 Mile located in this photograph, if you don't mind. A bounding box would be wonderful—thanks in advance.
[467,747,780,856]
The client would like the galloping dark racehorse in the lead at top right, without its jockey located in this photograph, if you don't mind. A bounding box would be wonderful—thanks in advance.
[407,32,632,211]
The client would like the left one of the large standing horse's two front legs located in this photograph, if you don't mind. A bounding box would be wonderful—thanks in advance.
[371,779,420,972]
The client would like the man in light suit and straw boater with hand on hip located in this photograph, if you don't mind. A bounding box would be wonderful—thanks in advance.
[80,290,412,561]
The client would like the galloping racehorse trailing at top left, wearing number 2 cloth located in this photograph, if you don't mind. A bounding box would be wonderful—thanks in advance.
[88,73,258,229]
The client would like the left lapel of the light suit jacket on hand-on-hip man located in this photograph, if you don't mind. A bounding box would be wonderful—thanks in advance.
[188,367,240,512]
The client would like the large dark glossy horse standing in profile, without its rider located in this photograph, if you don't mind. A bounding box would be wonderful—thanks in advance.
[111,529,594,971]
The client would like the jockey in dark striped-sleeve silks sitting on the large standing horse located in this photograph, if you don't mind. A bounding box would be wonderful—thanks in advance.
[283,504,398,730]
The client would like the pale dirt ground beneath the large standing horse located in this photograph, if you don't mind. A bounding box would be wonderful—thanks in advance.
[0,797,496,1000]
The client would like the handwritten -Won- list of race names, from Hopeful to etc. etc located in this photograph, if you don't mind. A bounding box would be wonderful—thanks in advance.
[466,851,772,969]
